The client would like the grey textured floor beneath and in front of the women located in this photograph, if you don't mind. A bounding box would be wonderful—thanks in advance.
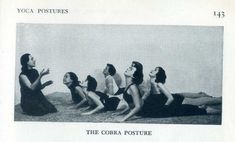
[15,92,221,125]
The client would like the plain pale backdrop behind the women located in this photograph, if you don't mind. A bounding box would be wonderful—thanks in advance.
[15,24,223,103]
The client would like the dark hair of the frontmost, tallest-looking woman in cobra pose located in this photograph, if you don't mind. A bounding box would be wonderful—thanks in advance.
[132,61,144,85]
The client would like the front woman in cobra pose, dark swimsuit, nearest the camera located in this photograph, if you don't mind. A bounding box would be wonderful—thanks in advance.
[120,62,220,122]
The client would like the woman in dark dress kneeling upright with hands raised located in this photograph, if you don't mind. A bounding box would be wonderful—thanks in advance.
[19,53,57,116]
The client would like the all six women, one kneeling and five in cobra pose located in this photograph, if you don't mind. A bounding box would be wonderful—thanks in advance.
[19,53,222,121]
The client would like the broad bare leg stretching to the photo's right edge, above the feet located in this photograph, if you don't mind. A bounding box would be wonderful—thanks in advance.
[182,97,222,106]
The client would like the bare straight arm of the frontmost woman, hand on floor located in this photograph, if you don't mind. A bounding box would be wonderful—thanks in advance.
[122,85,141,121]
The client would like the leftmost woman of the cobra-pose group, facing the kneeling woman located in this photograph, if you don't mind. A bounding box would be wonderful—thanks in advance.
[63,72,87,108]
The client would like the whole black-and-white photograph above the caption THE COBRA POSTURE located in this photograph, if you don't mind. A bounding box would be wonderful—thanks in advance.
[14,23,224,125]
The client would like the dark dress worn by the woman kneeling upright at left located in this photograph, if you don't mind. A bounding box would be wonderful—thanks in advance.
[20,69,57,116]
